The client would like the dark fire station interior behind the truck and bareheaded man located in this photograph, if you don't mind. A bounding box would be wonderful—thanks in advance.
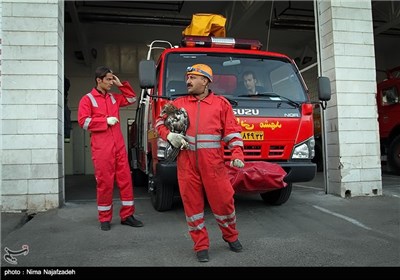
[64,1,400,201]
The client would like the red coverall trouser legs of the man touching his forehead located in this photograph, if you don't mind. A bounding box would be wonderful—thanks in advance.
[92,144,135,222]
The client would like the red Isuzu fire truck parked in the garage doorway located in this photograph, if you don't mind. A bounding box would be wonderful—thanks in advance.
[129,36,330,211]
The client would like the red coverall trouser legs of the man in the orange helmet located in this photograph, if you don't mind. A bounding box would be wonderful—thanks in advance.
[178,149,238,252]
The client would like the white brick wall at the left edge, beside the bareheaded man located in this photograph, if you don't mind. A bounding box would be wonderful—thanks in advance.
[1,0,64,212]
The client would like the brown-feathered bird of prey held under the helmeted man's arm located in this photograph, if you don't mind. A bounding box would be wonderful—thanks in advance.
[161,102,189,162]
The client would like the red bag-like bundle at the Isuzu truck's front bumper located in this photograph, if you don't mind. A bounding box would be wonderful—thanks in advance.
[225,161,287,193]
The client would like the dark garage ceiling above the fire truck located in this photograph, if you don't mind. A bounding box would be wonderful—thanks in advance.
[65,1,400,67]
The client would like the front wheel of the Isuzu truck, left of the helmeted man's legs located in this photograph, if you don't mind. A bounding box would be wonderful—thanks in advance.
[148,163,174,212]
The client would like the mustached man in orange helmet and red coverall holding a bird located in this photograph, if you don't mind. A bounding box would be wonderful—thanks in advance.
[156,64,244,262]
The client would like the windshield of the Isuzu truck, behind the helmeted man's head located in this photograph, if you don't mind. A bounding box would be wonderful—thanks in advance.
[163,52,308,104]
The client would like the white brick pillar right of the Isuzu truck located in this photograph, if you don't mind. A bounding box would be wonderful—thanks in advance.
[317,0,382,197]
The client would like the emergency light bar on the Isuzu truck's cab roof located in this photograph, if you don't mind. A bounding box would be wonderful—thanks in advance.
[181,36,262,50]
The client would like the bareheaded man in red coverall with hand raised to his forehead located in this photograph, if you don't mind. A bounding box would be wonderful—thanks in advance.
[78,66,143,230]
